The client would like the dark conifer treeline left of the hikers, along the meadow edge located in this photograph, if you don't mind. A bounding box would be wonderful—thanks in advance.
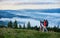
[0,20,39,30]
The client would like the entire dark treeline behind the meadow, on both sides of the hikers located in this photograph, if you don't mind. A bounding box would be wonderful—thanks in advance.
[0,20,60,32]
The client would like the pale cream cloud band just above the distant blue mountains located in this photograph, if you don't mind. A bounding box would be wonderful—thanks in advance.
[0,4,60,10]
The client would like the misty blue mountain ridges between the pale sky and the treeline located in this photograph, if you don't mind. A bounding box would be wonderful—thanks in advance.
[0,8,60,27]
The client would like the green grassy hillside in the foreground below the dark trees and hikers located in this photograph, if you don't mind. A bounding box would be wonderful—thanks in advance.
[0,28,60,38]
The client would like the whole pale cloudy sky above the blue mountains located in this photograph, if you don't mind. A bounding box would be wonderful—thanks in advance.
[0,0,60,10]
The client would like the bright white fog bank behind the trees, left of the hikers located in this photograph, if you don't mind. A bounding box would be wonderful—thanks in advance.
[0,17,40,26]
